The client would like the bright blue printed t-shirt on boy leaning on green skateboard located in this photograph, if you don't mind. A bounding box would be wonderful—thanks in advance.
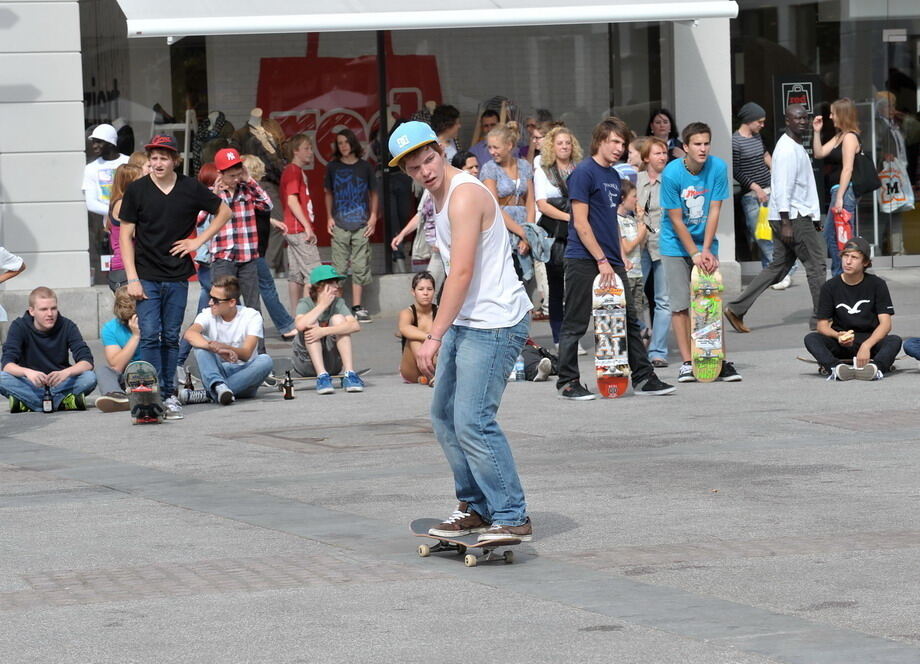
[659,156,730,256]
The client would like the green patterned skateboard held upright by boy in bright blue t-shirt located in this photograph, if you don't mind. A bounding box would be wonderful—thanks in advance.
[690,266,725,383]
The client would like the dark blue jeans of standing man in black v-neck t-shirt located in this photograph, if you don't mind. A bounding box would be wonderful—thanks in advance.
[137,279,188,399]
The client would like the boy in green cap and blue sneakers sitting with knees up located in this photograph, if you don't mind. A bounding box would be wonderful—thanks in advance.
[294,265,364,394]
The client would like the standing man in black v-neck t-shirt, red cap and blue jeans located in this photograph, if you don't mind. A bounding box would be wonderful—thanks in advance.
[120,136,230,419]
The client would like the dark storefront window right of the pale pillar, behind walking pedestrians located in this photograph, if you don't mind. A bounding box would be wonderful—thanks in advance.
[732,0,920,266]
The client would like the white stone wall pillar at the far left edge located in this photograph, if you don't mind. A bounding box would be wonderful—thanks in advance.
[0,0,90,292]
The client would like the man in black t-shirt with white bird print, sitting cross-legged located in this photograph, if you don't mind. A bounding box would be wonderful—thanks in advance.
[805,237,901,380]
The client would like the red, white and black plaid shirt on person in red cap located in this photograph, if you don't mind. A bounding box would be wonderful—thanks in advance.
[211,180,272,263]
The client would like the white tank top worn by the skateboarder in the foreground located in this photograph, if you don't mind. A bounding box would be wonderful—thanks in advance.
[435,171,531,329]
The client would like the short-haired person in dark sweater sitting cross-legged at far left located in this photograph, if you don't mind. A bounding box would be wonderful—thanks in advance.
[0,286,96,413]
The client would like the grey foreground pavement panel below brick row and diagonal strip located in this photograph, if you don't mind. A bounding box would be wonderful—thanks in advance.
[0,580,772,664]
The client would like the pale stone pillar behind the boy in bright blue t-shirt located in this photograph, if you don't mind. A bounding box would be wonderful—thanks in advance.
[672,18,741,290]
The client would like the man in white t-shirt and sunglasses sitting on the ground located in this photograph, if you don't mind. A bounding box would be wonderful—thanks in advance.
[179,275,273,406]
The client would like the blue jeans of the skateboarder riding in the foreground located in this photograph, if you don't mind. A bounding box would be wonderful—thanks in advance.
[431,314,530,526]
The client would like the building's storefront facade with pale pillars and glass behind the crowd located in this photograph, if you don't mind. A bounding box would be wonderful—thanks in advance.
[0,0,920,308]
